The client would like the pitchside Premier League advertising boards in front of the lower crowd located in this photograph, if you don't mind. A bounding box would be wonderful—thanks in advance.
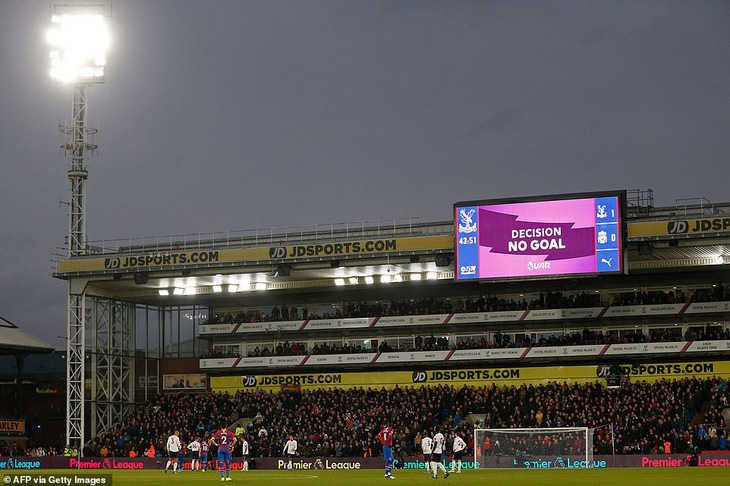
[0,452,730,471]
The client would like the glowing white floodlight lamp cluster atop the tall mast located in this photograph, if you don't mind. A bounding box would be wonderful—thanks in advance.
[46,9,109,83]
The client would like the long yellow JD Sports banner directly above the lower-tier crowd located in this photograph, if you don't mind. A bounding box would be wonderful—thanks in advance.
[210,361,730,394]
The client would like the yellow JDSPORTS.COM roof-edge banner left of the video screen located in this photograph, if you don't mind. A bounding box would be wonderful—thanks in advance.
[58,235,454,273]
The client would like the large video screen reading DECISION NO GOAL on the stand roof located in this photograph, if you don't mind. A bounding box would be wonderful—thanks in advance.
[454,193,624,280]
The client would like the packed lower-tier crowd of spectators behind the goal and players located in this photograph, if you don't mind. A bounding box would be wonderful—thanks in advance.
[77,378,730,457]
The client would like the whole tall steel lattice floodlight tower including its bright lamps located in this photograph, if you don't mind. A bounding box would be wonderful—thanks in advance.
[47,3,109,447]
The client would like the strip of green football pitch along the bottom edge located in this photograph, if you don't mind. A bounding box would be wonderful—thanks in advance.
[0,467,730,486]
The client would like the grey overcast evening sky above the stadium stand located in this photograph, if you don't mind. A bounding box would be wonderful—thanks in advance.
[0,0,730,347]
